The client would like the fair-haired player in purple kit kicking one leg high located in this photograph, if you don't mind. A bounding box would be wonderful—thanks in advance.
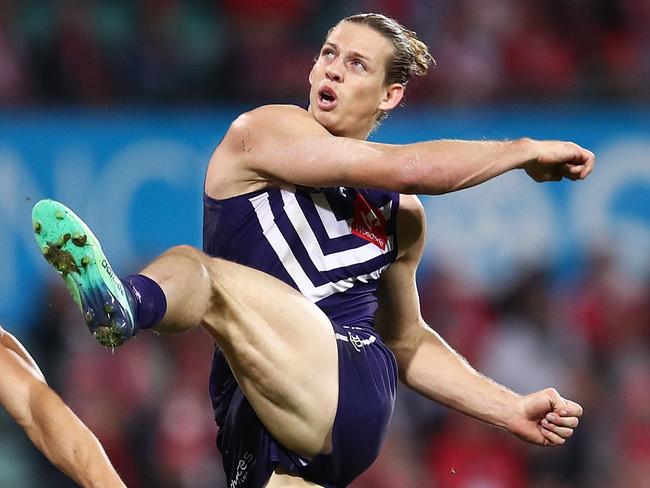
[32,14,594,488]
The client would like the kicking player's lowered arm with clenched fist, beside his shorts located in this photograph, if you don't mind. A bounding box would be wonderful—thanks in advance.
[377,196,582,445]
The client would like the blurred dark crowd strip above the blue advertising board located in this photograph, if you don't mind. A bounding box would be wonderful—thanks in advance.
[0,0,650,107]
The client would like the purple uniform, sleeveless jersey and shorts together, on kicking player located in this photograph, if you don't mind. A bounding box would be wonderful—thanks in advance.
[203,186,399,488]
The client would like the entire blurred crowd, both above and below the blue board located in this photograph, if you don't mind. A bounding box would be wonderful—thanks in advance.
[0,0,650,488]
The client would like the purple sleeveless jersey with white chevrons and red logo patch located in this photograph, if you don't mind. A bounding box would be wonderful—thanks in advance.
[203,185,399,327]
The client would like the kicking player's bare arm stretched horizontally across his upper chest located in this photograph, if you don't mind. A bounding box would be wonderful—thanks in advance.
[206,106,593,198]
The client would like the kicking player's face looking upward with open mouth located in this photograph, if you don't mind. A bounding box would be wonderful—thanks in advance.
[309,22,404,139]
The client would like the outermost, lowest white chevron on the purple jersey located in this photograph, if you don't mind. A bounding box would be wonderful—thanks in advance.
[249,193,388,302]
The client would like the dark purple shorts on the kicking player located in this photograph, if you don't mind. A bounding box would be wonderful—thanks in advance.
[210,325,397,488]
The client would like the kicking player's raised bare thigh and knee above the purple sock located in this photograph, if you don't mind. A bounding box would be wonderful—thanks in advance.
[142,246,338,458]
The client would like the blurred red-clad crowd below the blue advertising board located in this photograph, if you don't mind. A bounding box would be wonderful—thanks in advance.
[0,248,650,488]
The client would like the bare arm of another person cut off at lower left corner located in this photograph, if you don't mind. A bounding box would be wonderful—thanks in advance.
[0,327,125,487]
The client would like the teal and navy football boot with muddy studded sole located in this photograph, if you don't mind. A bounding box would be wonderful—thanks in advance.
[32,200,137,348]
